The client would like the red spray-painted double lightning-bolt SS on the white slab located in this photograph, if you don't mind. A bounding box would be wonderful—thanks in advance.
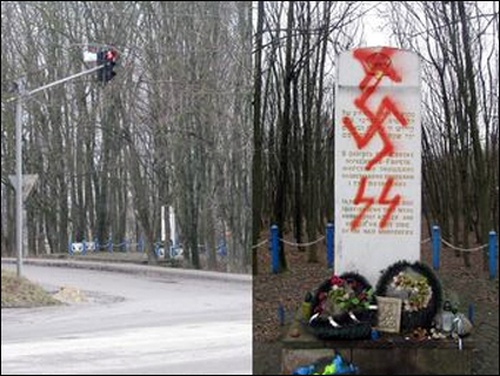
[351,176,401,231]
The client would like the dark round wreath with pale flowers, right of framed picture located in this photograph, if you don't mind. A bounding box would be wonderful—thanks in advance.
[375,261,442,333]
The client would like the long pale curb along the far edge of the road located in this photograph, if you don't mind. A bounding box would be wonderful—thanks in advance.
[2,257,252,283]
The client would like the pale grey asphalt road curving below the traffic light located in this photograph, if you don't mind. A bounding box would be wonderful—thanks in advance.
[2,264,252,374]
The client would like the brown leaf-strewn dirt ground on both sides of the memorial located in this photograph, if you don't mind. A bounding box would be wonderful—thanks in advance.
[253,231,499,375]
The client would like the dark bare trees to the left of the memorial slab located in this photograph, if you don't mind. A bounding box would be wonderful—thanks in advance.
[254,1,362,270]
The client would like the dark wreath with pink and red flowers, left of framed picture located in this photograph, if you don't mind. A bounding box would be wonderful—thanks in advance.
[309,273,376,340]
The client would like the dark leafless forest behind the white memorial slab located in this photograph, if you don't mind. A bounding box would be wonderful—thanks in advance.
[252,1,499,274]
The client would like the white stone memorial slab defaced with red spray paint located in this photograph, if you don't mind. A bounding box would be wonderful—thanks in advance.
[334,47,421,286]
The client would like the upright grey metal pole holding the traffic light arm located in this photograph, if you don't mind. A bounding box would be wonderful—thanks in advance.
[16,79,24,277]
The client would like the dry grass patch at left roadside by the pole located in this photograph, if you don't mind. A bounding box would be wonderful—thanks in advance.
[2,269,61,308]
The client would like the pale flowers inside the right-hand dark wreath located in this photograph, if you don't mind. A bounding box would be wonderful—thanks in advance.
[391,271,432,311]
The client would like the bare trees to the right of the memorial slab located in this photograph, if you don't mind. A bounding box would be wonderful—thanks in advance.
[391,1,498,267]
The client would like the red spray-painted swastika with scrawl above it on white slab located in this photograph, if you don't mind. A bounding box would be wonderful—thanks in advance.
[342,47,408,170]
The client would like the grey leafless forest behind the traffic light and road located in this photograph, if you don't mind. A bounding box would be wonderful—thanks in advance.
[1,1,252,272]
